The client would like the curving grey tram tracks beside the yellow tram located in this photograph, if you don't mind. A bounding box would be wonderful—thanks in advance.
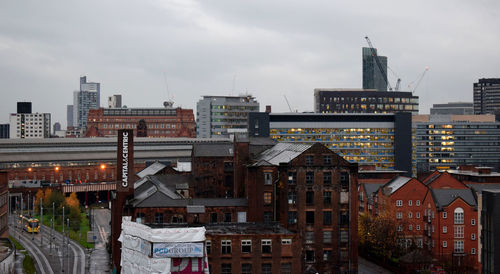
[10,215,86,274]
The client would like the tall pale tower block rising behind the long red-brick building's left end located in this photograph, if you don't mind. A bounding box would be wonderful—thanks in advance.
[73,76,101,131]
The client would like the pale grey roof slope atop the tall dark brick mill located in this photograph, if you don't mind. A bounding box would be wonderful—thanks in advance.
[253,143,312,166]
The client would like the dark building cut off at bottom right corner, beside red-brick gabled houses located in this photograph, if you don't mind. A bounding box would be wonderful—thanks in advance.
[481,190,500,273]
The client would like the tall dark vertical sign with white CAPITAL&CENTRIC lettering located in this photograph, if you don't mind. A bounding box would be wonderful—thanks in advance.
[116,129,134,192]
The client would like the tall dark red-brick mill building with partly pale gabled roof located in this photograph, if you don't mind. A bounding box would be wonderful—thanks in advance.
[246,143,358,273]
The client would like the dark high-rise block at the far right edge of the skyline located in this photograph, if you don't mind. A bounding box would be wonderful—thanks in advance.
[474,78,500,114]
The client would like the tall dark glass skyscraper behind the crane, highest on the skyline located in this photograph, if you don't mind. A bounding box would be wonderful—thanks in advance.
[363,48,387,91]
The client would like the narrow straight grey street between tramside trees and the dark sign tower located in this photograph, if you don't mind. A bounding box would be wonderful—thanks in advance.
[90,209,111,273]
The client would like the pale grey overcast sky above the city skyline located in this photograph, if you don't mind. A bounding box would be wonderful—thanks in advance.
[0,0,500,128]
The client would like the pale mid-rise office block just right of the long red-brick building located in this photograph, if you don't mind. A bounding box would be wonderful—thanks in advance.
[196,95,259,138]
